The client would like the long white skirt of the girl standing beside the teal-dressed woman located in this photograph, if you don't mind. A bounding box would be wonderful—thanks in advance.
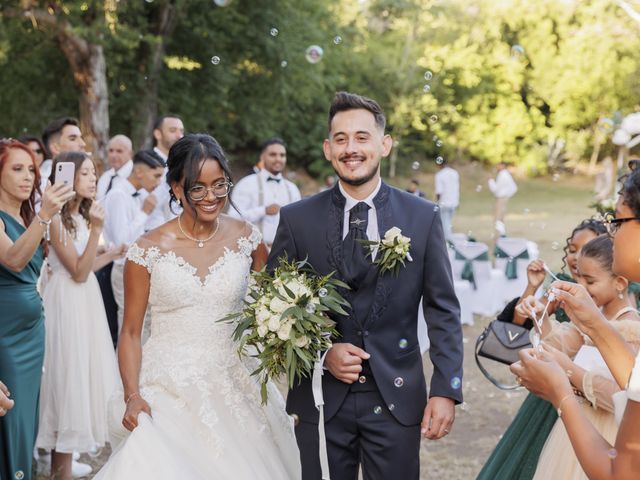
[36,271,120,453]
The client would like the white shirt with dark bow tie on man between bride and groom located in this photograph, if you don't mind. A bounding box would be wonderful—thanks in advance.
[229,170,301,245]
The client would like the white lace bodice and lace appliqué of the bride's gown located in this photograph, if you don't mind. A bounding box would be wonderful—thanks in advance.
[127,227,289,452]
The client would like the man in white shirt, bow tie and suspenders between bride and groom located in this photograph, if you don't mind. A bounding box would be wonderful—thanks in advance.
[229,138,300,247]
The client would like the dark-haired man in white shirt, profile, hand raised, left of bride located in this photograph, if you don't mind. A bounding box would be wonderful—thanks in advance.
[103,150,164,332]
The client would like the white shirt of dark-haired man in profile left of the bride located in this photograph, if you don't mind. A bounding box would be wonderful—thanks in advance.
[103,180,149,264]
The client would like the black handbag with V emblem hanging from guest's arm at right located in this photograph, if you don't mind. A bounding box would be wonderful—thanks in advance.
[475,320,531,390]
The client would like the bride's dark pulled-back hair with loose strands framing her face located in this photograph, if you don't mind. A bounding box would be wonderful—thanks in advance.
[167,133,235,215]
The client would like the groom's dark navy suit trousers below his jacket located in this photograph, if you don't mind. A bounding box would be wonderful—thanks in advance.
[295,390,420,480]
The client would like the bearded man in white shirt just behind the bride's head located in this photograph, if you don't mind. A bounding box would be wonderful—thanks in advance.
[145,114,184,230]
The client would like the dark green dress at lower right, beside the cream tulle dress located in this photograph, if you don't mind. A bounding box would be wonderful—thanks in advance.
[476,273,575,480]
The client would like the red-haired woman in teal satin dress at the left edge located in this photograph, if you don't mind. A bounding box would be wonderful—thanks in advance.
[0,140,74,480]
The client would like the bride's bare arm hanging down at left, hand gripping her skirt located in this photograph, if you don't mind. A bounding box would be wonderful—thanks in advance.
[118,261,151,431]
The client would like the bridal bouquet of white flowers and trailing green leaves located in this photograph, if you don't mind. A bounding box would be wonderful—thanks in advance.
[221,259,349,403]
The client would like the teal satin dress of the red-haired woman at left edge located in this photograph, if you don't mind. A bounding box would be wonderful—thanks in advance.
[0,211,44,480]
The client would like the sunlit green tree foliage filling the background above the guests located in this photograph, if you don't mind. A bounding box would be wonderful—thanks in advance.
[0,0,640,175]
